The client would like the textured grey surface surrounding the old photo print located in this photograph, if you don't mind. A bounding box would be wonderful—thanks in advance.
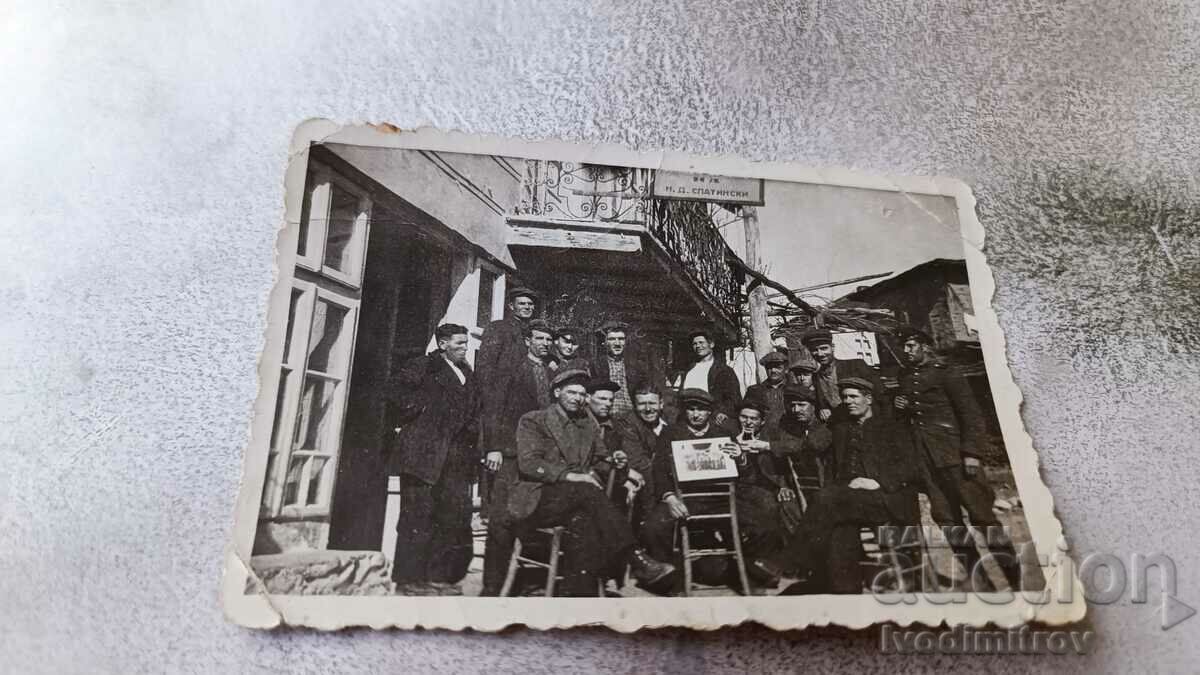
[0,0,1200,673]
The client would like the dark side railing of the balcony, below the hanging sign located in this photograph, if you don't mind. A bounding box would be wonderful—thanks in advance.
[647,199,744,325]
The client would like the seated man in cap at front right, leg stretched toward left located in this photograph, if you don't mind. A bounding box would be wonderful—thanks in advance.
[752,377,924,593]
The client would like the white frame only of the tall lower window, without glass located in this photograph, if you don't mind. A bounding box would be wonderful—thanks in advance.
[260,280,359,520]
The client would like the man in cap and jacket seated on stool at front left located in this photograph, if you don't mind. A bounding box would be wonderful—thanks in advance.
[509,370,674,596]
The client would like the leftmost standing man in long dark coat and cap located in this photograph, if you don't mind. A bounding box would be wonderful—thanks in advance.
[389,323,479,595]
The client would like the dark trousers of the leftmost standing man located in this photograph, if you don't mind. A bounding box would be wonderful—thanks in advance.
[391,467,474,584]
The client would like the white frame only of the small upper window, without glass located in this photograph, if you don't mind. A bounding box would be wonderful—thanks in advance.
[296,161,373,288]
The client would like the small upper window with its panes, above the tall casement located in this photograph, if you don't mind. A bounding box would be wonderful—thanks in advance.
[296,162,371,288]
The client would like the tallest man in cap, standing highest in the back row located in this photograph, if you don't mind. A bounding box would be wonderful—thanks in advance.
[475,286,540,512]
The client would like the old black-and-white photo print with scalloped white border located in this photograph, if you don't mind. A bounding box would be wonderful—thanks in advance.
[222,120,1085,632]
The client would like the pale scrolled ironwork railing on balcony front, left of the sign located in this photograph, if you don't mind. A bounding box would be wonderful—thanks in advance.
[515,160,650,225]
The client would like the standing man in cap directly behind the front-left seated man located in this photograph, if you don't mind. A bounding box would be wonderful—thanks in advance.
[482,318,551,596]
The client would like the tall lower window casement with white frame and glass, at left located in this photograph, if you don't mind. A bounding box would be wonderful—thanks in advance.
[262,281,358,518]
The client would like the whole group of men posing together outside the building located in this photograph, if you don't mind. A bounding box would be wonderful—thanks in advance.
[389,283,1020,596]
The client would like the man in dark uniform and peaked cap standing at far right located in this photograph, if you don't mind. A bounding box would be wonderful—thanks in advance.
[893,328,1021,591]
